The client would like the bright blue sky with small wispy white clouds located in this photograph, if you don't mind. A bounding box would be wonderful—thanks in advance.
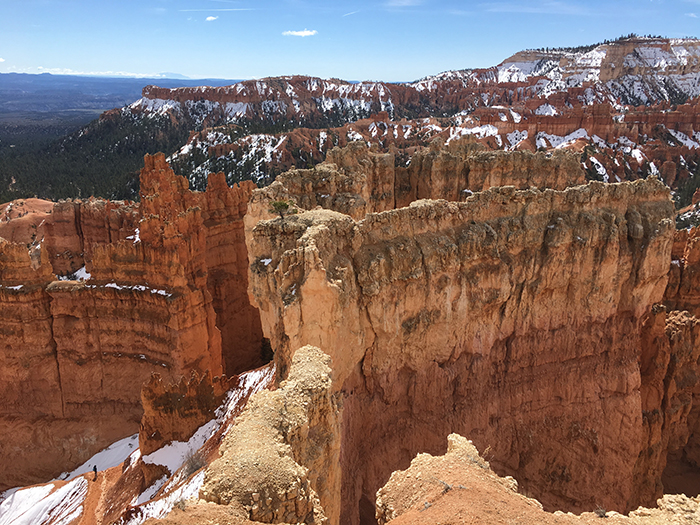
[0,0,700,81]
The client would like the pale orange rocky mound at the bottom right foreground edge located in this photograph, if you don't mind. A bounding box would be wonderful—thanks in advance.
[377,434,700,525]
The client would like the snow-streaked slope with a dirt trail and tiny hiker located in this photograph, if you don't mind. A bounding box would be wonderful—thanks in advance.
[0,365,275,525]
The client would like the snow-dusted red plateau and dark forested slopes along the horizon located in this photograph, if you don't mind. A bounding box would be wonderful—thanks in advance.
[0,37,700,205]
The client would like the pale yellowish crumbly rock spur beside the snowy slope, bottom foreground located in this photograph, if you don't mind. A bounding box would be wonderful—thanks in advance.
[200,346,341,523]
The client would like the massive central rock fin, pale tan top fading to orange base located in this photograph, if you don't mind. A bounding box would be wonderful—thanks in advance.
[247,180,674,523]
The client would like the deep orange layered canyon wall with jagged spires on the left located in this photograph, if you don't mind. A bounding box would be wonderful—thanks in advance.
[0,154,263,490]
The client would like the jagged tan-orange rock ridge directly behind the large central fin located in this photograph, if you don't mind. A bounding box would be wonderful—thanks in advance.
[267,137,586,220]
